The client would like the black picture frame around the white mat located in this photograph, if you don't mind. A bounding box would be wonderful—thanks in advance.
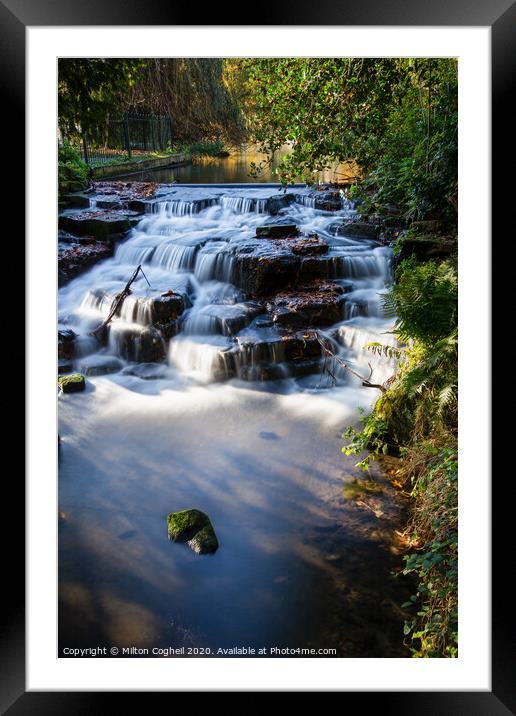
[4,0,510,716]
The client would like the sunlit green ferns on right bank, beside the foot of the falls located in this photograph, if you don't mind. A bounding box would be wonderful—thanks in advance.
[344,259,458,467]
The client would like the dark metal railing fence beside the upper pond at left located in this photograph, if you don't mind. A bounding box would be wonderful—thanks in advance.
[70,114,172,165]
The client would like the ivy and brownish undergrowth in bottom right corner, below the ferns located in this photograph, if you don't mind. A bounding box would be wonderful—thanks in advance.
[403,445,458,658]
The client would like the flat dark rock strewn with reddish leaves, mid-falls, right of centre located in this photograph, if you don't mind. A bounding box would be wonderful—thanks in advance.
[266,281,346,326]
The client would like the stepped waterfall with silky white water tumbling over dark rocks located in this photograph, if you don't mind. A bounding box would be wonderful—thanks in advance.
[59,186,393,382]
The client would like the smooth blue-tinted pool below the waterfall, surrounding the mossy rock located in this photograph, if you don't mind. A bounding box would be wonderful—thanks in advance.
[59,381,412,656]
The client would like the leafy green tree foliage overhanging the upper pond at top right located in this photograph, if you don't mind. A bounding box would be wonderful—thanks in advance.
[241,58,457,224]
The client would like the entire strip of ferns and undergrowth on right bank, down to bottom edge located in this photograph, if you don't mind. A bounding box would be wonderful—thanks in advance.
[343,259,458,657]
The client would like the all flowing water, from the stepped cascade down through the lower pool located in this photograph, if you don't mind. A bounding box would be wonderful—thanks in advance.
[59,186,412,656]
